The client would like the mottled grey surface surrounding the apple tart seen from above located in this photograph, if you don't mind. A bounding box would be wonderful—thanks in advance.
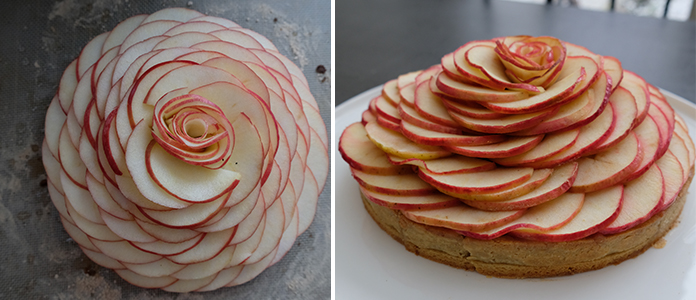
[0,0,332,299]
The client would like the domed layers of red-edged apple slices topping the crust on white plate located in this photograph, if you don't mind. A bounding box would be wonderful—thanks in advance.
[339,36,696,277]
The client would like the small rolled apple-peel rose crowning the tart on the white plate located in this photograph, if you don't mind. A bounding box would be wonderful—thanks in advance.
[495,36,566,88]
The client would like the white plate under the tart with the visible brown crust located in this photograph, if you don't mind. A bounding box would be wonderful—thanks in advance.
[334,87,696,300]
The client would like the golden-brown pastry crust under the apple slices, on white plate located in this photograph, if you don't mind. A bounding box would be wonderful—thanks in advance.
[361,168,694,278]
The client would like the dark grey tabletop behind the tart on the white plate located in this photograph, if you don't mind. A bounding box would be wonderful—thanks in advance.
[335,0,696,105]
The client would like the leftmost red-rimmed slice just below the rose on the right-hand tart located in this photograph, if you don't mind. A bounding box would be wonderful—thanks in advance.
[432,72,528,102]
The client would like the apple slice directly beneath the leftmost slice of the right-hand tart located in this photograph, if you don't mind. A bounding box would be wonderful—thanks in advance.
[351,169,437,196]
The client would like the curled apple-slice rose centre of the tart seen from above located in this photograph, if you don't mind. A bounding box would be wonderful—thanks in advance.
[152,94,234,169]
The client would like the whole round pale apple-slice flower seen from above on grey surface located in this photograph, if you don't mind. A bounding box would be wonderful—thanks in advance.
[43,8,328,292]
